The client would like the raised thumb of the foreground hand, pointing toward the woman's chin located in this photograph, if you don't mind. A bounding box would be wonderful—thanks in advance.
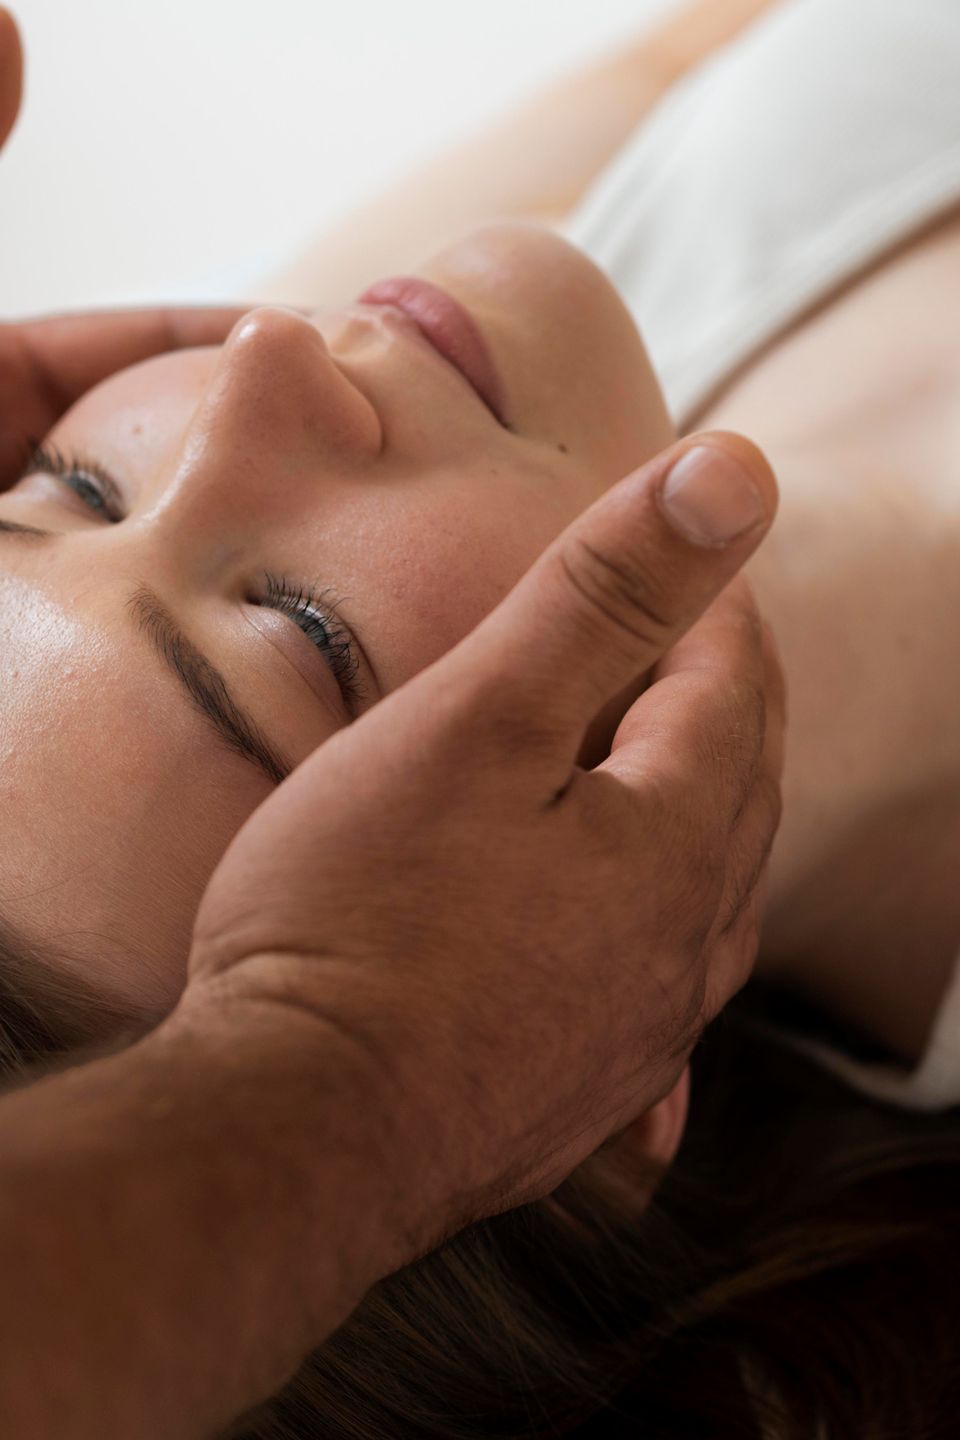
[446,431,777,762]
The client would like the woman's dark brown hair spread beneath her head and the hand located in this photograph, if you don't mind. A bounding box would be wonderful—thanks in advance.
[0,921,960,1440]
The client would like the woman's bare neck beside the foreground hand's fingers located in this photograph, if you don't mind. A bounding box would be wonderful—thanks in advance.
[747,448,960,1060]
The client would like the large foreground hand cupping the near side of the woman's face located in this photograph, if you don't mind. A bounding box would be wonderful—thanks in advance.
[181,435,783,1263]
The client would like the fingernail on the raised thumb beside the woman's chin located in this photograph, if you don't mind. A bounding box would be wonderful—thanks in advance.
[661,445,767,546]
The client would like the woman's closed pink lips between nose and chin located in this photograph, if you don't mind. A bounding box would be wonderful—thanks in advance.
[357,275,507,425]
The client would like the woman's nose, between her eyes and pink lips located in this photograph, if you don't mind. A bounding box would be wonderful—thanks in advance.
[142,305,383,564]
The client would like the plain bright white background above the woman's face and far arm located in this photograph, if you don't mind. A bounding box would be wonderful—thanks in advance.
[0,0,676,315]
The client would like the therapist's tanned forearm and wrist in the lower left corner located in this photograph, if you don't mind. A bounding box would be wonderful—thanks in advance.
[0,976,416,1440]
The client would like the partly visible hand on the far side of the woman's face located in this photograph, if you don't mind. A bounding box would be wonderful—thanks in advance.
[0,7,249,490]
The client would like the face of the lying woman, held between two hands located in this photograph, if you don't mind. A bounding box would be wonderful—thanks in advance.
[0,225,672,1018]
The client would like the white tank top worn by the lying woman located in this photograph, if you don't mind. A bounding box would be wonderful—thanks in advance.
[564,0,960,1110]
